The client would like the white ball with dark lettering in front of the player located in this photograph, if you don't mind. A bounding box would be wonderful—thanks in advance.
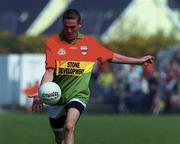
[38,82,61,105]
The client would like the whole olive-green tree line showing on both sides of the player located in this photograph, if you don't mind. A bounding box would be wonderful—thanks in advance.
[0,32,180,56]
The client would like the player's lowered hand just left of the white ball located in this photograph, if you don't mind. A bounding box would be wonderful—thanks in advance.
[32,96,43,112]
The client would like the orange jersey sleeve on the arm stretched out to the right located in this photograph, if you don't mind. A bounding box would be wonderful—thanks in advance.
[96,39,113,63]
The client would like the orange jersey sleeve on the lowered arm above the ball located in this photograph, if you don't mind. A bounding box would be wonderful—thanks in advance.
[45,43,56,69]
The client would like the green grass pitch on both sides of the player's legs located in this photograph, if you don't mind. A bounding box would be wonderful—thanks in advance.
[0,113,180,144]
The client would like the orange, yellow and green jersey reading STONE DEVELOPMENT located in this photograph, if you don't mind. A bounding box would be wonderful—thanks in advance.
[45,33,113,104]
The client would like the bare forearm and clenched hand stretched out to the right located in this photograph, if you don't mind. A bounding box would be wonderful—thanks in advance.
[109,53,154,65]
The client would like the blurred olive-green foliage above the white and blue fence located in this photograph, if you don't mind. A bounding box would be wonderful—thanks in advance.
[0,32,46,54]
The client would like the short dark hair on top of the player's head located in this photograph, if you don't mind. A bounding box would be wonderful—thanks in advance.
[63,9,81,22]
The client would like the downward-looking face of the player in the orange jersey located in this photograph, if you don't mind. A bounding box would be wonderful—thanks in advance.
[63,19,81,41]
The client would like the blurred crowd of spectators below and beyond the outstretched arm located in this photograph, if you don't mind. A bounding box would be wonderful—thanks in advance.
[90,50,180,114]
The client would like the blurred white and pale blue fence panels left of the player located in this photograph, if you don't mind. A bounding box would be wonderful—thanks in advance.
[0,54,45,107]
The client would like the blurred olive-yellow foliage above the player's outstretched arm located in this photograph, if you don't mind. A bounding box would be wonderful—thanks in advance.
[105,35,180,57]
